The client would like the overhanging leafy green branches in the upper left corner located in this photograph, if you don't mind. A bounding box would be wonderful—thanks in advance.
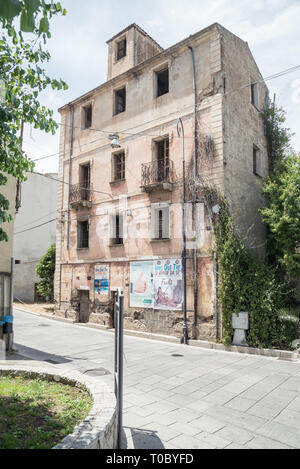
[0,0,67,241]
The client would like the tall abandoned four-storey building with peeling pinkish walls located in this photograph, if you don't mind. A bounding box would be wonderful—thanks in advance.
[55,24,268,339]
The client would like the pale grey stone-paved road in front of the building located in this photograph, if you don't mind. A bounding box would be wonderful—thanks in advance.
[10,310,300,449]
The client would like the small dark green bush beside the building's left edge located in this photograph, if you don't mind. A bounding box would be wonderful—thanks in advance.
[36,244,56,300]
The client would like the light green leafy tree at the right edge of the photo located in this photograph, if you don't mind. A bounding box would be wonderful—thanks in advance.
[261,155,300,277]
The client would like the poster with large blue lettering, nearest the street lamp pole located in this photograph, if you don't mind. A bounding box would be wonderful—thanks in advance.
[153,259,182,310]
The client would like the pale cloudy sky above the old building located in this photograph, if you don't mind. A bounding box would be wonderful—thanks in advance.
[24,0,300,173]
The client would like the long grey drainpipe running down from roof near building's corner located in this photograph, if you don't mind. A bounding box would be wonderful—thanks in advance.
[188,46,198,336]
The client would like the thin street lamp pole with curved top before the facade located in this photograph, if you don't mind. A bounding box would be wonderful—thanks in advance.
[177,118,188,345]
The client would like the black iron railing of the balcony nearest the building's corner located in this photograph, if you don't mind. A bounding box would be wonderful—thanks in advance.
[141,160,174,187]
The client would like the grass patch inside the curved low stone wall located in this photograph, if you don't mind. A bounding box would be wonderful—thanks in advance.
[0,376,92,449]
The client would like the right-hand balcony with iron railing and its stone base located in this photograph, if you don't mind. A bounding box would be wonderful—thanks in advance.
[141,160,174,192]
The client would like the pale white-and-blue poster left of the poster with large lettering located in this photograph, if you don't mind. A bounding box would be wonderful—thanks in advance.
[130,261,153,308]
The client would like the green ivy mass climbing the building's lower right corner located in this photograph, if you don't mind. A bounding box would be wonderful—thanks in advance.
[214,201,297,348]
